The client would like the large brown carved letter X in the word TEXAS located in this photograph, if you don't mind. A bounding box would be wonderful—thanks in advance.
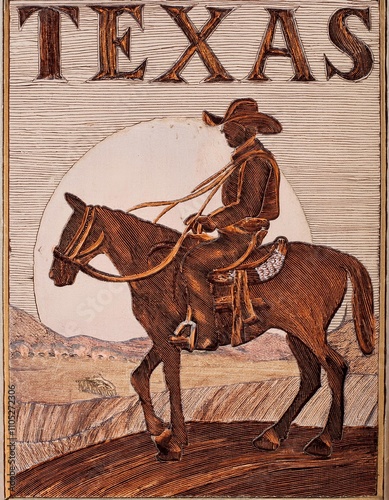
[154,5,234,82]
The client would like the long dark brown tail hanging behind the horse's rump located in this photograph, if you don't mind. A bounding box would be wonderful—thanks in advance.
[344,255,375,354]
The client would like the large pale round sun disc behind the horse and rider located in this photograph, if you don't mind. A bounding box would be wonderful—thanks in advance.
[34,119,312,341]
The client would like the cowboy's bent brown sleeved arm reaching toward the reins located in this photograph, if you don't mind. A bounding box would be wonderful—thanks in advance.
[209,156,272,228]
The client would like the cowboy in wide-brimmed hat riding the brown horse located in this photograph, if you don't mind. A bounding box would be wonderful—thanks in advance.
[171,99,282,350]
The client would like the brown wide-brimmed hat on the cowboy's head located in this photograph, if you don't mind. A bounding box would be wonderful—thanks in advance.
[203,98,282,134]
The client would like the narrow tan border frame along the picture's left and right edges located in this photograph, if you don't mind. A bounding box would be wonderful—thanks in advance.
[0,0,389,500]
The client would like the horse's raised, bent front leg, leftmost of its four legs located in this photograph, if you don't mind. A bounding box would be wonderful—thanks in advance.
[131,346,166,436]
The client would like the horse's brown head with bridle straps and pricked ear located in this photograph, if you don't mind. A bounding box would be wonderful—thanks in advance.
[49,193,104,286]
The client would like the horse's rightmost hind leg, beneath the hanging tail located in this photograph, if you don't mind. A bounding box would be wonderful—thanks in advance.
[304,344,348,457]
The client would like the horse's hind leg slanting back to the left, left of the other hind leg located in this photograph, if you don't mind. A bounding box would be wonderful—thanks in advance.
[253,335,320,451]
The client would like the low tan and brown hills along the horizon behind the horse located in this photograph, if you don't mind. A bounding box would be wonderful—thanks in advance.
[9,307,378,374]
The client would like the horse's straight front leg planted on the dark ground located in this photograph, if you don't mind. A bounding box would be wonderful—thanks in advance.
[154,343,188,462]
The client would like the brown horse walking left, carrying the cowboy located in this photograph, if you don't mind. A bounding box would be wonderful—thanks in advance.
[49,193,374,461]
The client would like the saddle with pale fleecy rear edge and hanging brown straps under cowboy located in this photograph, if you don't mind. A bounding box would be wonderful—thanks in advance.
[208,237,287,347]
